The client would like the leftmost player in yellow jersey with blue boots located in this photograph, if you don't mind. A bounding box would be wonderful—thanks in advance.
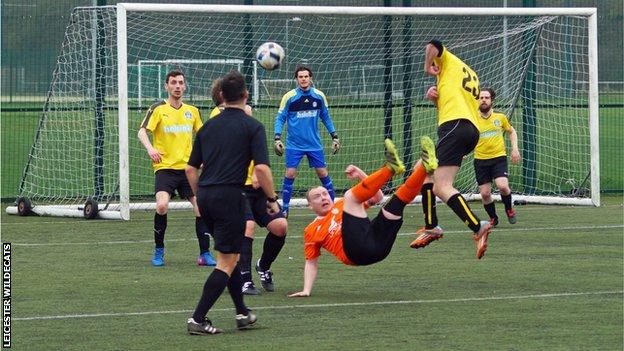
[138,71,217,266]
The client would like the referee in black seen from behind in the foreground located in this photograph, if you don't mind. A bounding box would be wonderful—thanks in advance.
[186,71,280,335]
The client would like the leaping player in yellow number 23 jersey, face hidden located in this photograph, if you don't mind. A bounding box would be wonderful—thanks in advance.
[410,40,492,259]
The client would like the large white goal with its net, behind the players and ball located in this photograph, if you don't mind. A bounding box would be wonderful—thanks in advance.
[9,4,600,219]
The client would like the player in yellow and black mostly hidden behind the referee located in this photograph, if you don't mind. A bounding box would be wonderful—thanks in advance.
[210,79,288,295]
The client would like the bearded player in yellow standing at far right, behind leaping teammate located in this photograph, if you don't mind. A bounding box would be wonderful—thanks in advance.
[474,88,520,226]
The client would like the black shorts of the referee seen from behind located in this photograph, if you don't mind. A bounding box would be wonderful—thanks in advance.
[197,185,247,254]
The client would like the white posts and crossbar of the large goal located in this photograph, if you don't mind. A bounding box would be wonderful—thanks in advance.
[117,3,600,219]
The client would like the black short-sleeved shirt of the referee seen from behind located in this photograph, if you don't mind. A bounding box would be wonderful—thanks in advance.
[188,108,269,186]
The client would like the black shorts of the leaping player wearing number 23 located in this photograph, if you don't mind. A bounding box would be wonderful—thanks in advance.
[436,119,479,167]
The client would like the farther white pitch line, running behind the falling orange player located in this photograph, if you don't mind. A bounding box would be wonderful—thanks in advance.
[6,224,624,247]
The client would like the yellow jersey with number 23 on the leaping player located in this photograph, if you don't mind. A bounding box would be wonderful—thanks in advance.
[433,47,480,127]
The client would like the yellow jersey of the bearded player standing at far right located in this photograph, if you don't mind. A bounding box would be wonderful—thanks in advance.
[475,112,511,160]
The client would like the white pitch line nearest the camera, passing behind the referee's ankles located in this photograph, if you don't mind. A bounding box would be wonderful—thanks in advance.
[13,290,624,321]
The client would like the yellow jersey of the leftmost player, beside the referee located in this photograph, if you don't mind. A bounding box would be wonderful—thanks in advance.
[141,101,202,172]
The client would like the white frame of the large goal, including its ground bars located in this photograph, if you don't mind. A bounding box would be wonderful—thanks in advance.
[7,3,600,220]
